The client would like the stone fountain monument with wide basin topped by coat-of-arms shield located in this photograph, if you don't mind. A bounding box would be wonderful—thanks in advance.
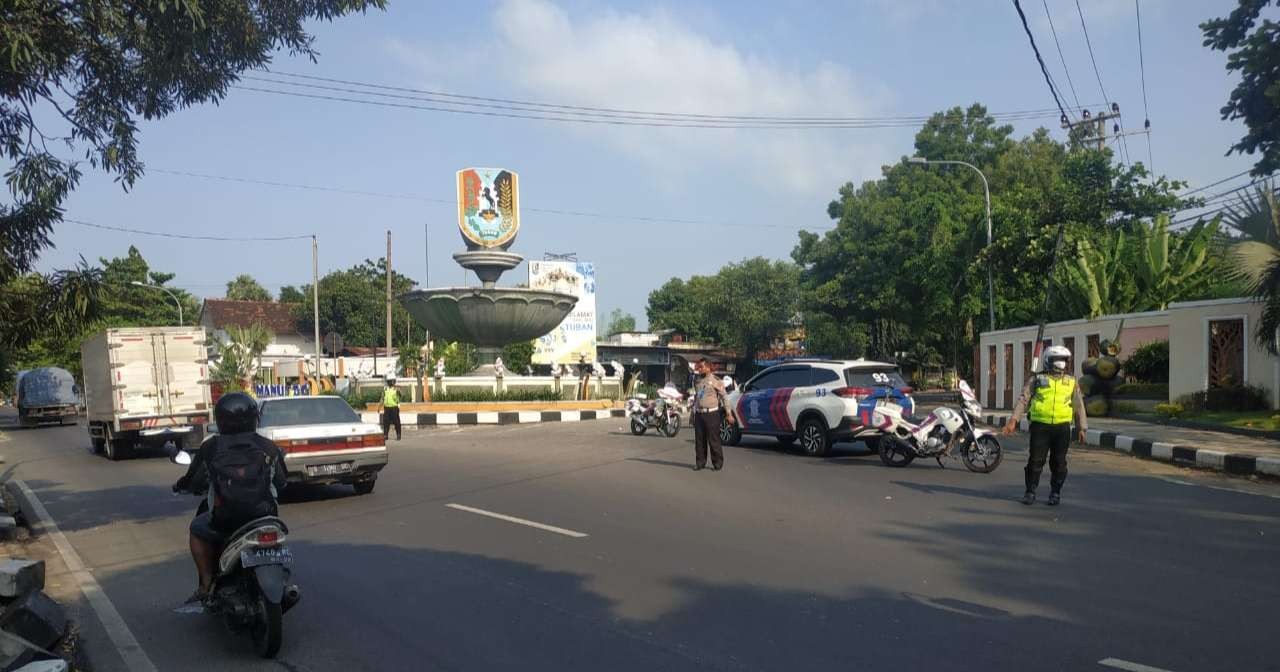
[399,168,577,376]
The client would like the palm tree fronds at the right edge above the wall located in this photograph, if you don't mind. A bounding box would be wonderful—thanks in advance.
[1225,180,1280,355]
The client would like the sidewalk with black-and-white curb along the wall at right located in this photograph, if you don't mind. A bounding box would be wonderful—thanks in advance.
[986,415,1280,477]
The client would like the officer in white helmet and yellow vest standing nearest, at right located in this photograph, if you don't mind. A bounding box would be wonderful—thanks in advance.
[1004,346,1088,507]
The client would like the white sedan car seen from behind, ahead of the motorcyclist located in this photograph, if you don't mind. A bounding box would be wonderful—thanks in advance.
[257,397,388,494]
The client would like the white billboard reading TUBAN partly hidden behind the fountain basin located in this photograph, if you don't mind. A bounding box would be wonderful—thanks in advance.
[529,261,595,365]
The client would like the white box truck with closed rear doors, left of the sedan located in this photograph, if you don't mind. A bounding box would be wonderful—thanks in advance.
[81,326,212,460]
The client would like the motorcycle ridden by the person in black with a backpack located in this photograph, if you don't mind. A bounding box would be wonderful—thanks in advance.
[170,448,301,658]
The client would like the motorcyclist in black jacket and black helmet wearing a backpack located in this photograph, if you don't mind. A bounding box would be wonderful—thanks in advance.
[173,392,287,602]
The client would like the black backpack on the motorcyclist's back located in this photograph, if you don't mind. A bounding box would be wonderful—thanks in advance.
[209,435,276,530]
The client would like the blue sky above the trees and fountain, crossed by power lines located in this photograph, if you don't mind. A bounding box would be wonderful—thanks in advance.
[32,0,1269,326]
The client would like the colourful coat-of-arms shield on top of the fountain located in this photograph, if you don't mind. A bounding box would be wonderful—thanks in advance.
[458,168,520,248]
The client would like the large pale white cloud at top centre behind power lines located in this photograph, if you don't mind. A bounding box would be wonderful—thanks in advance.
[397,0,888,195]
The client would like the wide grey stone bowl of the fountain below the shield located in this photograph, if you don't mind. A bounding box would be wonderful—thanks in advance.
[399,287,577,348]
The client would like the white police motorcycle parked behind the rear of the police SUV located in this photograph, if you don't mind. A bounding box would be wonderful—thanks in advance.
[872,380,1004,474]
